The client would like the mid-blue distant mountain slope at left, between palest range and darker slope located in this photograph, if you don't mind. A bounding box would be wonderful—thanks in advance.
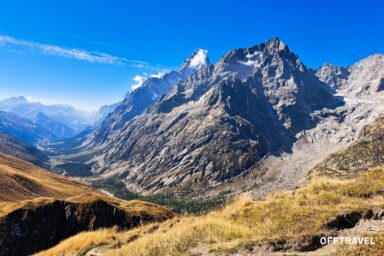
[0,111,56,145]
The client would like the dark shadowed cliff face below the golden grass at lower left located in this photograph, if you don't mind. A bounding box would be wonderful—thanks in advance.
[0,200,167,256]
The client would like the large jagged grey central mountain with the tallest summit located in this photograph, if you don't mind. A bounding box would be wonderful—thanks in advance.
[84,38,343,193]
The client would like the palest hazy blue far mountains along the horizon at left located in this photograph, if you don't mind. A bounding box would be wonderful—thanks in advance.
[0,96,115,138]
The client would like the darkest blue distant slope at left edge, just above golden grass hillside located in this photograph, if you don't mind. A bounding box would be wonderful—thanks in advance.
[0,132,48,168]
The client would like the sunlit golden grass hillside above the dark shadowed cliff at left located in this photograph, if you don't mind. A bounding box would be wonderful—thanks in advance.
[0,151,173,219]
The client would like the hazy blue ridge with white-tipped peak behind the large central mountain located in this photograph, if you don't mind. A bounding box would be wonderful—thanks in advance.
[88,49,210,147]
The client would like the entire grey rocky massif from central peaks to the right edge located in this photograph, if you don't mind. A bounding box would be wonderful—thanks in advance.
[56,38,383,196]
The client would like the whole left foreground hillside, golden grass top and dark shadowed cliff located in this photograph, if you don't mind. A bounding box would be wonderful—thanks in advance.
[0,154,173,255]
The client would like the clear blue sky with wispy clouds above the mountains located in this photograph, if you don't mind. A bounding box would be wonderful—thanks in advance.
[0,0,384,110]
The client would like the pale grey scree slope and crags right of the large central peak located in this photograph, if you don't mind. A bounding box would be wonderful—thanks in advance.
[208,54,384,200]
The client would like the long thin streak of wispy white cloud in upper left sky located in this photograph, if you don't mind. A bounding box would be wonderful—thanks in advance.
[0,35,167,71]
